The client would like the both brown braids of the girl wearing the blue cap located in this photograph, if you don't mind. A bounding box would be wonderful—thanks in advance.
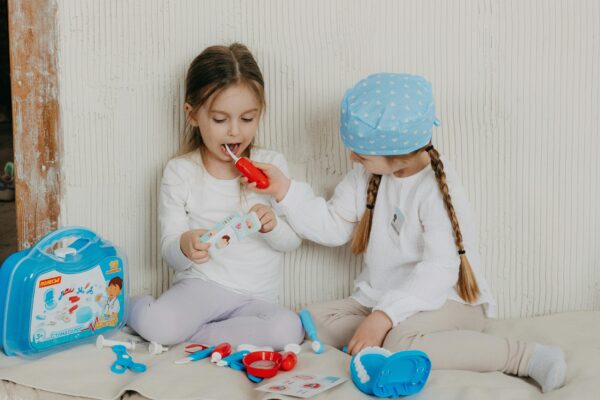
[351,145,480,303]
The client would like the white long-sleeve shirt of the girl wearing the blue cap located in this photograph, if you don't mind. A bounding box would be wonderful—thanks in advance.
[276,160,496,326]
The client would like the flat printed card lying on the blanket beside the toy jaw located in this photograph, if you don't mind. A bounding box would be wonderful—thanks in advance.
[256,374,347,399]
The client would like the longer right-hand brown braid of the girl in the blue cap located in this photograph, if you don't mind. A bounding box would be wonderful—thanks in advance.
[426,145,479,303]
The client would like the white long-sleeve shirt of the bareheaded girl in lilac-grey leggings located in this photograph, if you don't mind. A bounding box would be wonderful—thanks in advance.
[159,149,301,302]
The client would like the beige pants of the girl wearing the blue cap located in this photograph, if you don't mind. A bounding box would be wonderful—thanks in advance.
[308,297,534,376]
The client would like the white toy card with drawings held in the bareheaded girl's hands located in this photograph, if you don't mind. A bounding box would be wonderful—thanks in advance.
[200,212,261,254]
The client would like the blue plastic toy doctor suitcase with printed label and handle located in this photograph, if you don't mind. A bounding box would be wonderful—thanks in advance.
[0,227,129,357]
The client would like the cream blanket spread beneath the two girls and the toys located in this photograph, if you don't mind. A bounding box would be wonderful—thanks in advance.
[0,312,600,400]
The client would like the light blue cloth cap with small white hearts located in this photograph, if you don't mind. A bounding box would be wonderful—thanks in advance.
[340,73,439,156]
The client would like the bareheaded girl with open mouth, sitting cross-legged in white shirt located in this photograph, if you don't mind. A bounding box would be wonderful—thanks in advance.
[128,43,302,349]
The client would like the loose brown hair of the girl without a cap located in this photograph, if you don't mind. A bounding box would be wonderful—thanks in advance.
[177,43,266,155]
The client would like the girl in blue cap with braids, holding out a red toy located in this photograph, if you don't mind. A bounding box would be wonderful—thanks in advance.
[244,73,566,392]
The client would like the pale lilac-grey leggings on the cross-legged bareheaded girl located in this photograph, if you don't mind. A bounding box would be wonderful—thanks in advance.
[127,279,304,350]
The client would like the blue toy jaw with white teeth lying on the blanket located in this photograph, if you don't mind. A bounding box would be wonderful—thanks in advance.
[350,347,431,398]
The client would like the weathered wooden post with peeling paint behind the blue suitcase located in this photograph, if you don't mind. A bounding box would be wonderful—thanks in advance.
[8,0,61,249]
